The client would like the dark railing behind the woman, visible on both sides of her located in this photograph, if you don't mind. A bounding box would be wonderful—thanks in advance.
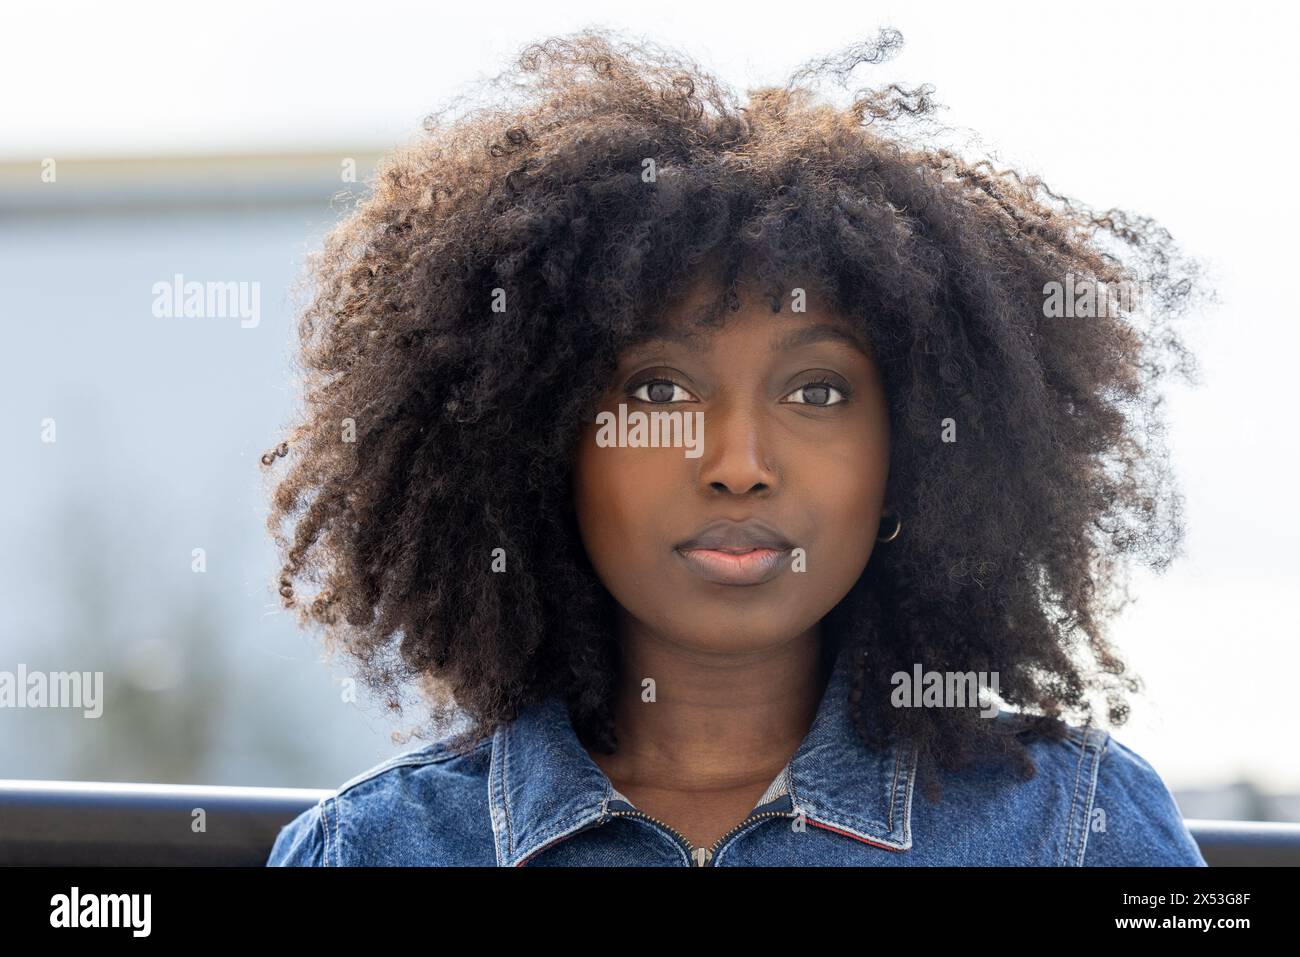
[0,780,1300,866]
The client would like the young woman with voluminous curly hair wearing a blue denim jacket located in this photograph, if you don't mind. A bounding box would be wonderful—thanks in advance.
[264,31,1204,866]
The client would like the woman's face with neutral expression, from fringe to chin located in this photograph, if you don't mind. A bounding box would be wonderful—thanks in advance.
[573,273,889,651]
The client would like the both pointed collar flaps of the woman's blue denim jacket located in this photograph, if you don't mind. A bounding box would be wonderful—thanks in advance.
[488,642,917,866]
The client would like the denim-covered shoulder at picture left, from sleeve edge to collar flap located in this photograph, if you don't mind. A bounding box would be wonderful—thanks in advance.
[267,737,495,867]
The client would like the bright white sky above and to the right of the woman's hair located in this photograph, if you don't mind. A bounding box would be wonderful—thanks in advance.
[0,0,1300,789]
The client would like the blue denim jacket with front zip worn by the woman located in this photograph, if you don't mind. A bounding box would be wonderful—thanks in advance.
[268,642,1205,867]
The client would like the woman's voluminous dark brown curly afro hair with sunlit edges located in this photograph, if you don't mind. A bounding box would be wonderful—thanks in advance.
[263,30,1197,793]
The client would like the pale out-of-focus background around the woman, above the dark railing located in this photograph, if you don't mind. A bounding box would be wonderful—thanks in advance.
[0,0,1300,820]
